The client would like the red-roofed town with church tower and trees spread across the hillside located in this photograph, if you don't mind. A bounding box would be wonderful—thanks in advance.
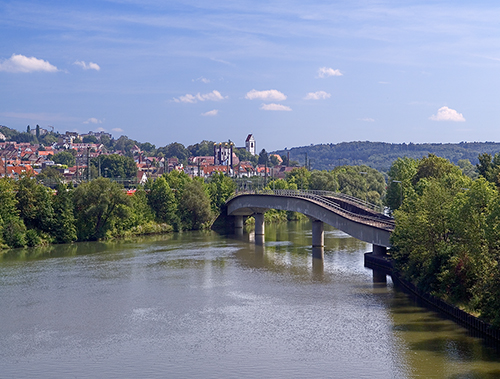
[0,125,297,186]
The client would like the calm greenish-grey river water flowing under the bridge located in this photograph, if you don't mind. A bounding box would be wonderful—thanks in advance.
[0,222,500,379]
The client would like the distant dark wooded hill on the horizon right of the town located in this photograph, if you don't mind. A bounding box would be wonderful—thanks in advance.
[273,141,500,172]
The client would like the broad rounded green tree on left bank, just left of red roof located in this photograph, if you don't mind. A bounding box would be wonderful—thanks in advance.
[73,178,130,241]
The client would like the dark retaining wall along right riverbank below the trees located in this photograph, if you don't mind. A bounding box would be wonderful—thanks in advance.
[365,253,500,342]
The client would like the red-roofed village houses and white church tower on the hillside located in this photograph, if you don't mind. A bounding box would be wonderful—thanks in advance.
[0,126,294,184]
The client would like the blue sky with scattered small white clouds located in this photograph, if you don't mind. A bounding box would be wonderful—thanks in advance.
[0,0,500,151]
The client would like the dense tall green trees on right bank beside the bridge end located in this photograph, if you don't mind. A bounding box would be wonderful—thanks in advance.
[386,154,500,327]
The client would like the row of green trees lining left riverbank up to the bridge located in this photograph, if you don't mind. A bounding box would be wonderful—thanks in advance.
[0,171,235,248]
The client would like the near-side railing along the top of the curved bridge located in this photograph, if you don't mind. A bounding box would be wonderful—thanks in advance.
[228,190,395,230]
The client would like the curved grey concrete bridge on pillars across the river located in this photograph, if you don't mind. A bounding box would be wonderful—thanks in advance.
[221,190,394,258]
